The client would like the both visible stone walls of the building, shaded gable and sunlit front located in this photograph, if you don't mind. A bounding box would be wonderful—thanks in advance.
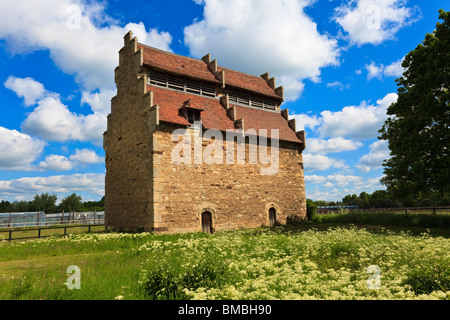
[104,33,306,232]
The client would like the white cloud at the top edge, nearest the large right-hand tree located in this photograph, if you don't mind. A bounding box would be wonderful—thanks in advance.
[333,0,415,45]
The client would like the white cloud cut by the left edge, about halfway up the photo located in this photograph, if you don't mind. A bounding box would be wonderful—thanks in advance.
[0,127,45,170]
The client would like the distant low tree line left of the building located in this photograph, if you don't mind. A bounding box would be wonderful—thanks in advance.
[0,193,105,213]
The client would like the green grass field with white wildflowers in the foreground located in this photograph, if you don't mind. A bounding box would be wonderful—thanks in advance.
[0,219,450,300]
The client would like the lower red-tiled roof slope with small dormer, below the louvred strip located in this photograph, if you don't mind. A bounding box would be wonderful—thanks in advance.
[147,85,302,143]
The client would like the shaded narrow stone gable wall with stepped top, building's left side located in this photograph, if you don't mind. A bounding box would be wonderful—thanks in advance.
[103,33,158,230]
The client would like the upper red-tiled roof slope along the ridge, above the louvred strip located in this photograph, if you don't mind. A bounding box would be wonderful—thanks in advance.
[137,43,281,99]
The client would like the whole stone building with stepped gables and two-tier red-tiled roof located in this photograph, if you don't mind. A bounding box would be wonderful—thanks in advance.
[104,32,306,232]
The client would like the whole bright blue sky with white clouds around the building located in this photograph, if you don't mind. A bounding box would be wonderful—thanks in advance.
[0,0,449,201]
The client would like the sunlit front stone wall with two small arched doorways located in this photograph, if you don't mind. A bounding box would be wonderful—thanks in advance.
[153,124,306,232]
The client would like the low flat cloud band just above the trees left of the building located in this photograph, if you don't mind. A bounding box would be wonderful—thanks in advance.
[0,173,105,199]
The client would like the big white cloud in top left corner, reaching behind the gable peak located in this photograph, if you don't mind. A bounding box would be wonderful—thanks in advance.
[0,0,172,91]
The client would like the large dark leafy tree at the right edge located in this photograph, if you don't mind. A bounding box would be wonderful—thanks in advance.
[379,9,450,200]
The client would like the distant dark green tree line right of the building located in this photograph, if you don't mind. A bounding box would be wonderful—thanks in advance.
[310,190,450,208]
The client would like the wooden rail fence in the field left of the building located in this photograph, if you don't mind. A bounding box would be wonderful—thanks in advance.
[0,211,105,229]
